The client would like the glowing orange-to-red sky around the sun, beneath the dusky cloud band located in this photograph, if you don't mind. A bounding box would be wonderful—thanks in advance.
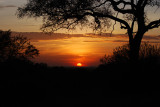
[30,34,126,66]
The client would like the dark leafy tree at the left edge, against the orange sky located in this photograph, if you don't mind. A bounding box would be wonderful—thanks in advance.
[0,31,39,62]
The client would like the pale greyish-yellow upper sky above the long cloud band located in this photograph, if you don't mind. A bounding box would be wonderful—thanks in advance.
[0,0,160,35]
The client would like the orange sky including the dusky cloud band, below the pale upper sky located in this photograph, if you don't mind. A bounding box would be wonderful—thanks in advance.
[13,33,160,66]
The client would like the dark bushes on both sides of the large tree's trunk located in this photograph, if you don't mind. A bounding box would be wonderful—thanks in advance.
[100,42,160,65]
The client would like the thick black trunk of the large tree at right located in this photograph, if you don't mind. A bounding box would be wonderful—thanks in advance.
[128,8,146,64]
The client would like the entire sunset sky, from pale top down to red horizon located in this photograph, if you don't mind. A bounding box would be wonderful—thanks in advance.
[0,0,160,66]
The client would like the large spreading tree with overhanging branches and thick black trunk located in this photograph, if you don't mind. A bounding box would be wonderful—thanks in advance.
[18,0,160,62]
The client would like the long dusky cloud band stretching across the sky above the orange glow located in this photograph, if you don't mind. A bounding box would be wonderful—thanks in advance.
[12,32,160,43]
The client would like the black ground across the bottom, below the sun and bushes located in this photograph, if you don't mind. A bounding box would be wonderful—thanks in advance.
[0,59,160,107]
